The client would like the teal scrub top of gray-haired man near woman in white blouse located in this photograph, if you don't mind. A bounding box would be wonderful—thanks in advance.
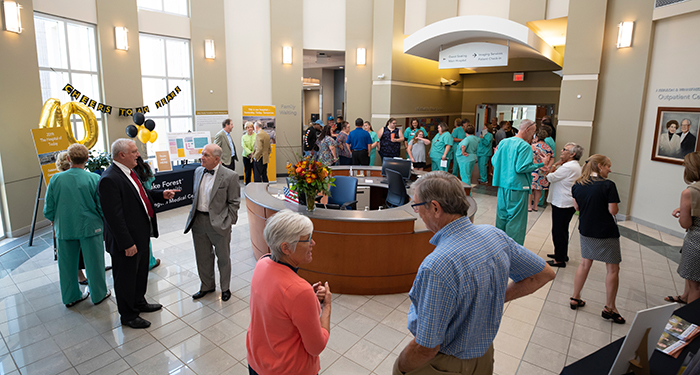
[491,137,544,190]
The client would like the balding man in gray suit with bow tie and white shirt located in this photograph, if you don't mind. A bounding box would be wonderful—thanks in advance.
[185,144,241,301]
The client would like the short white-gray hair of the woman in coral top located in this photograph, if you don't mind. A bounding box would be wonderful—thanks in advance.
[263,209,314,260]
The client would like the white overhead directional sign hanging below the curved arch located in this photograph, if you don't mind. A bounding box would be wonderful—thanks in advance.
[439,43,508,69]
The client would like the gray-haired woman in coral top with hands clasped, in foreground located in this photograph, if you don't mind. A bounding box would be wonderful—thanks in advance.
[246,210,331,375]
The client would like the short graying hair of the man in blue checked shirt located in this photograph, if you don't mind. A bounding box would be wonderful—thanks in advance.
[413,171,469,216]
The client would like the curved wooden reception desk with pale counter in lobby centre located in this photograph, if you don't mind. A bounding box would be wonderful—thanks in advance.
[245,174,477,295]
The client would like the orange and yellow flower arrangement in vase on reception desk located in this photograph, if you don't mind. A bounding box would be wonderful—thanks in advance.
[287,156,335,211]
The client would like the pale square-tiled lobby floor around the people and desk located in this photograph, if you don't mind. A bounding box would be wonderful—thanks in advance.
[0,187,683,375]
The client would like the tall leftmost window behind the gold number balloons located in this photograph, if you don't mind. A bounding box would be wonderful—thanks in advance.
[34,14,105,150]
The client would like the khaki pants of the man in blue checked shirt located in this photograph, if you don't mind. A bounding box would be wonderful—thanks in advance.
[393,344,493,375]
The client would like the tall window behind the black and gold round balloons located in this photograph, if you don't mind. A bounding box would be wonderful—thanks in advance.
[139,34,194,155]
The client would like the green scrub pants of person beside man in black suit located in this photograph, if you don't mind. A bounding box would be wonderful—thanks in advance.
[56,235,107,305]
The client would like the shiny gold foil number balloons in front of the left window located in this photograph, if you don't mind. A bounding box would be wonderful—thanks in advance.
[39,98,99,149]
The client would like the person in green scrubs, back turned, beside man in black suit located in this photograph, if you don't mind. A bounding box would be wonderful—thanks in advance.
[44,143,110,307]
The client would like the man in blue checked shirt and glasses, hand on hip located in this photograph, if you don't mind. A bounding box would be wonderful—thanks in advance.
[393,171,555,375]
